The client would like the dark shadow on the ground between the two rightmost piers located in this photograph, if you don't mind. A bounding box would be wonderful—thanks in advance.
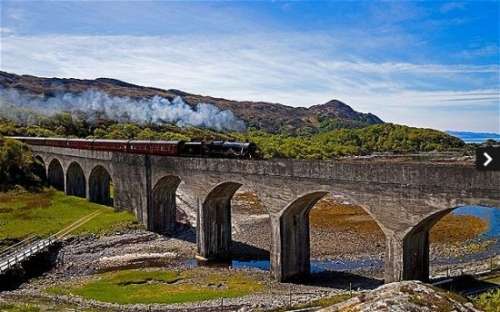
[290,271,384,290]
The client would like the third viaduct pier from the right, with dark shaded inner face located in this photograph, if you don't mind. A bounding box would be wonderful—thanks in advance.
[197,182,242,260]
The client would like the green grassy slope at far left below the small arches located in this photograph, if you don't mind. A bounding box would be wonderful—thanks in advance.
[0,189,139,245]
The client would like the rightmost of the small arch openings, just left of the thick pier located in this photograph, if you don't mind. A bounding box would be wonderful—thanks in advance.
[89,165,113,206]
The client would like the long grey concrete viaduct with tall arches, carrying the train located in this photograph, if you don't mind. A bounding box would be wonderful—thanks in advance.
[31,145,500,282]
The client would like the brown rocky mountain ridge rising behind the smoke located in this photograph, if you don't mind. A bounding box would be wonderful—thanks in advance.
[0,71,383,133]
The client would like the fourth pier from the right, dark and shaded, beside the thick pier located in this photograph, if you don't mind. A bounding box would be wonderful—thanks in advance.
[148,175,181,233]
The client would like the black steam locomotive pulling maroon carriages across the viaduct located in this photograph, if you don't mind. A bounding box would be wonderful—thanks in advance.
[6,137,258,159]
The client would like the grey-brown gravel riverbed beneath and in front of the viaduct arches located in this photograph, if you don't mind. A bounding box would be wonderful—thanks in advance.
[0,194,500,311]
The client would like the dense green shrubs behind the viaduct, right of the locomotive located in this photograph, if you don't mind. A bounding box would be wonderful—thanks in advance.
[236,124,465,159]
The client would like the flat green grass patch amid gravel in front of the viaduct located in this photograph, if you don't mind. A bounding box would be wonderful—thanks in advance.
[47,268,264,304]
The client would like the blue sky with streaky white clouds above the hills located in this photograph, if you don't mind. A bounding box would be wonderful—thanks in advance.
[0,0,500,132]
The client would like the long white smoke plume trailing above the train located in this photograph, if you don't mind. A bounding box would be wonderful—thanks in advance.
[0,88,245,131]
